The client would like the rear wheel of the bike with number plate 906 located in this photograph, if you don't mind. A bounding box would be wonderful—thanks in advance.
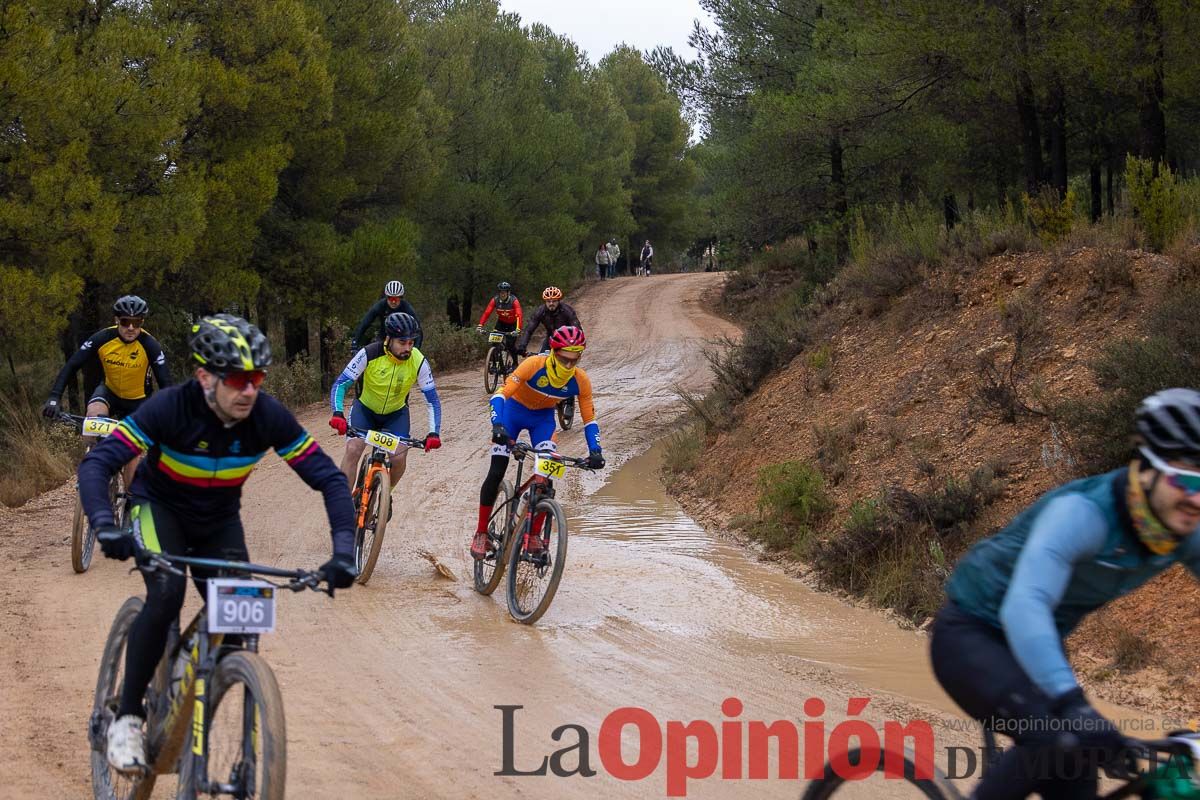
[88,597,155,800]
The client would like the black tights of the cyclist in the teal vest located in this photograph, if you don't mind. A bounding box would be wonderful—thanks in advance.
[929,601,1097,800]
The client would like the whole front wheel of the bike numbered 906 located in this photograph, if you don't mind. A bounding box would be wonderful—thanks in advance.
[176,651,288,800]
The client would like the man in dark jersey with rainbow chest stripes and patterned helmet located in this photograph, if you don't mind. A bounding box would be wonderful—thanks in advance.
[79,314,356,774]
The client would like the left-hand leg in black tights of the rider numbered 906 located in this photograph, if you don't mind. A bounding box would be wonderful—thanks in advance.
[116,500,187,720]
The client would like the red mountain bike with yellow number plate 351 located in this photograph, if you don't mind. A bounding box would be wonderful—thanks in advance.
[475,441,592,625]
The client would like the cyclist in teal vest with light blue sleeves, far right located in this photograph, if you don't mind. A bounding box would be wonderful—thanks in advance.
[930,389,1200,800]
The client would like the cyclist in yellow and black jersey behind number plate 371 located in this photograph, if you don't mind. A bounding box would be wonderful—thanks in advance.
[42,295,170,486]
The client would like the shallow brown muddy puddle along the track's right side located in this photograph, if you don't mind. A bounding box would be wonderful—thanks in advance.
[554,445,954,710]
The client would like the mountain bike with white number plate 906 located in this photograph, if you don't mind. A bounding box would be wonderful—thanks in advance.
[88,551,334,800]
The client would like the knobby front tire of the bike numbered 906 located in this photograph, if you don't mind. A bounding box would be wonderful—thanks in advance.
[176,651,288,800]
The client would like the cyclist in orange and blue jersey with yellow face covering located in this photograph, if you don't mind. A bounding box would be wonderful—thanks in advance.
[470,325,605,560]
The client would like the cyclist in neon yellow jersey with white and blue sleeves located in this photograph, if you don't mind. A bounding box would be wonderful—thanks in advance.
[329,312,442,488]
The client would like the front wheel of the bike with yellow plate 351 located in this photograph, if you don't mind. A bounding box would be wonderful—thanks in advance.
[508,498,566,625]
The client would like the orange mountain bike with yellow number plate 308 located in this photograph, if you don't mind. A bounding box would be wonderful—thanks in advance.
[346,428,425,584]
